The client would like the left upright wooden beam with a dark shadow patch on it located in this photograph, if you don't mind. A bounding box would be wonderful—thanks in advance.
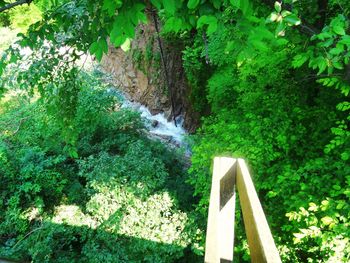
[205,157,236,263]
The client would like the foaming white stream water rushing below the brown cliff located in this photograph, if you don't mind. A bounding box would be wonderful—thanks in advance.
[107,88,186,146]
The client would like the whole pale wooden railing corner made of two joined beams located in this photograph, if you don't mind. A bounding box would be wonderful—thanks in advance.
[205,157,281,263]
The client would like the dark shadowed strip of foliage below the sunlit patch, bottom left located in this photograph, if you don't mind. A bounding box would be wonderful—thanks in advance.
[0,219,203,263]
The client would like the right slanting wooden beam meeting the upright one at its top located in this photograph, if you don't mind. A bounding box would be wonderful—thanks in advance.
[236,159,281,263]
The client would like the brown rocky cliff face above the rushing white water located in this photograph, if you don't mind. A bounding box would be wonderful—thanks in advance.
[101,17,200,133]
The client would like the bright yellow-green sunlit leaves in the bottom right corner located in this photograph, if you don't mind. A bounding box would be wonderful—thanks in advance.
[286,198,350,262]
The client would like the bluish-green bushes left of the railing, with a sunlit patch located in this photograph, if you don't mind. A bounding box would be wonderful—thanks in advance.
[0,73,201,262]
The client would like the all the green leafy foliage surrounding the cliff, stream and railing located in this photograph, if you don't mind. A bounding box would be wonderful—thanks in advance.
[0,0,350,262]
